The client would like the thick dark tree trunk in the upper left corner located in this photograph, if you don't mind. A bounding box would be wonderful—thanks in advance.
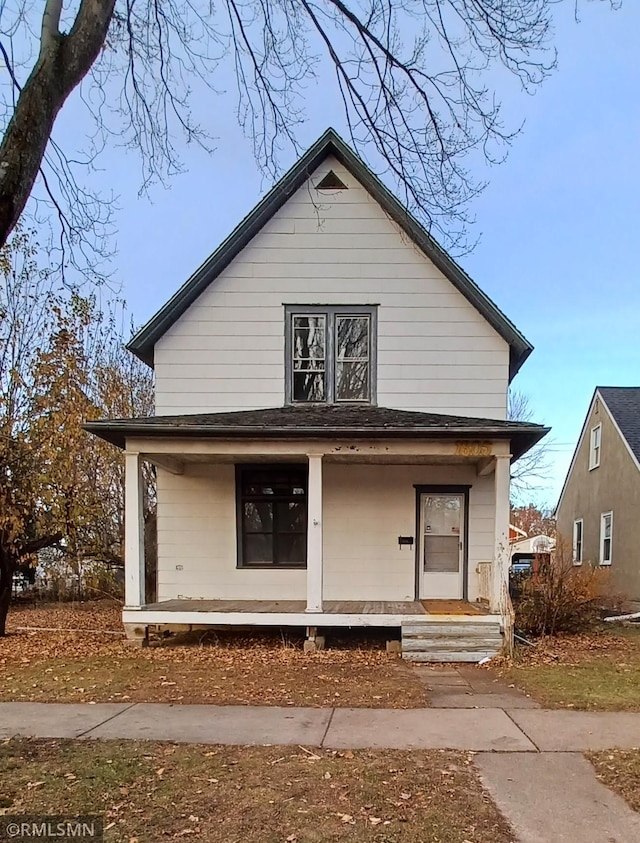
[0,0,115,246]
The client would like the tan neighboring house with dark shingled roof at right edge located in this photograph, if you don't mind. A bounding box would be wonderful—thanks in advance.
[556,386,640,602]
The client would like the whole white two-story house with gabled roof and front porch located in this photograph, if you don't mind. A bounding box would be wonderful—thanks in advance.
[86,130,547,660]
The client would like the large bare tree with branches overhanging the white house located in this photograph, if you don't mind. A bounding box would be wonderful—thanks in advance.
[0,0,616,271]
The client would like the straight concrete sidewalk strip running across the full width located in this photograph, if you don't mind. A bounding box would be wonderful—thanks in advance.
[0,703,640,753]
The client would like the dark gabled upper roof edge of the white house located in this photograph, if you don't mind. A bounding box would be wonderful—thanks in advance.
[127,129,533,378]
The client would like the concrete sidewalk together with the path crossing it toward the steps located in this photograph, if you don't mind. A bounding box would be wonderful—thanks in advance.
[0,700,640,843]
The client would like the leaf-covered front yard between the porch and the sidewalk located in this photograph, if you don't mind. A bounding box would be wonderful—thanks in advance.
[0,603,428,708]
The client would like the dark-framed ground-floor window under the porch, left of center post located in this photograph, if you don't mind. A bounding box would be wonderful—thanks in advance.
[236,465,308,568]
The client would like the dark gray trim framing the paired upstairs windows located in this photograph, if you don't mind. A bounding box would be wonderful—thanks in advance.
[284,304,378,407]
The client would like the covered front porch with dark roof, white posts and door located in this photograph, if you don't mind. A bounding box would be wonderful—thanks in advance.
[82,406,543,656]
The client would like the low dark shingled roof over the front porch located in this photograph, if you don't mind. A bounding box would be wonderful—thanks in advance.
[84,404,549,459]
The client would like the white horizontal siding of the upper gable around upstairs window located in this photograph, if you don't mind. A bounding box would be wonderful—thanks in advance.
[155,160,509,418]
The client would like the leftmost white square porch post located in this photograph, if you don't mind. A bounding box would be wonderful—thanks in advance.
[124,451,145,609]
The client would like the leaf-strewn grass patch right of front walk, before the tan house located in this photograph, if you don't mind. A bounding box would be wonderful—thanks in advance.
[499,627,640,711]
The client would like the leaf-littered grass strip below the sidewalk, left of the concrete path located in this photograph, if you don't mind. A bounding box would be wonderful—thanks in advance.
[0,740,514,843]
